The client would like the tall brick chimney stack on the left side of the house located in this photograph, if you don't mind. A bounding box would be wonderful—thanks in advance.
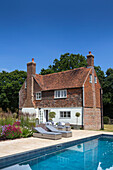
[26,58,36,107]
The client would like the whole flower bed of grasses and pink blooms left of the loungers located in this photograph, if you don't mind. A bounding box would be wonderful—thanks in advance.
[0,113,35,140]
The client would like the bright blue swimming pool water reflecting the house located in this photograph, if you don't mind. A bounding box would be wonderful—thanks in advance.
[2,137,113,170]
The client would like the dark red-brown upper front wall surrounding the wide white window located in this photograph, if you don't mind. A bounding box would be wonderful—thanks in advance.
[35,88,82,108]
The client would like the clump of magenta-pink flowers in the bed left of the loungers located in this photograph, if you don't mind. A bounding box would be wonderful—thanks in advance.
[2,125,22,139]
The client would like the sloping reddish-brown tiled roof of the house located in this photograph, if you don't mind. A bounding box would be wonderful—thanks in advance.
[35,67,91,91]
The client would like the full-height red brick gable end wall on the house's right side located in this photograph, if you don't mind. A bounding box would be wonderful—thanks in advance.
[83,68,101,130]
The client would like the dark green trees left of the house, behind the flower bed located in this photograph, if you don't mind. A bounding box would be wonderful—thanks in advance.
[0,70,27,112]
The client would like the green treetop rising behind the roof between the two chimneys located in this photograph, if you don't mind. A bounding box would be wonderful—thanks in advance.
[40,53,87,75]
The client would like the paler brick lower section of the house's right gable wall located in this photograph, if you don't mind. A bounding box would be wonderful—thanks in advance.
[83,108,101,130]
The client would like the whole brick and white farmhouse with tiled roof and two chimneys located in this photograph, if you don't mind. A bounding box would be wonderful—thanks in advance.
[19,52,103,129]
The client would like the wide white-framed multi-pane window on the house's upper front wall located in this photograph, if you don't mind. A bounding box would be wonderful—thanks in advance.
[54,90,67,98]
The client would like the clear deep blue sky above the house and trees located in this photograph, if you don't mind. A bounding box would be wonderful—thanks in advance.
[0,0,113,73]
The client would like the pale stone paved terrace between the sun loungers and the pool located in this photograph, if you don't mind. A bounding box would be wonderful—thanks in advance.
[0,130,113,157]
